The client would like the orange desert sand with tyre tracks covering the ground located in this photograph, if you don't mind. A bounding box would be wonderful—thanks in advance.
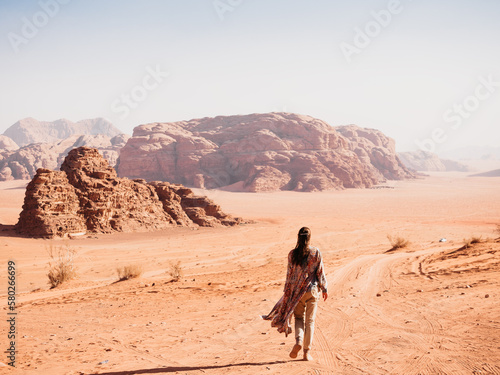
[0,173,500,375]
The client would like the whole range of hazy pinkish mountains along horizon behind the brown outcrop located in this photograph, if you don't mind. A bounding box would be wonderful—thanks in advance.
[0,113,490,187]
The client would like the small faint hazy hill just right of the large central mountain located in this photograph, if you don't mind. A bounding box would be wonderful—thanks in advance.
[398,150,470,172]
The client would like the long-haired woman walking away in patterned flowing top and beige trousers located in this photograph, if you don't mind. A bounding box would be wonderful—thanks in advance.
[262,227,328,361]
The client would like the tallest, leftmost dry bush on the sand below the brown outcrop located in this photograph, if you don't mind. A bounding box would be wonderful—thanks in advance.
[47,243,76,288]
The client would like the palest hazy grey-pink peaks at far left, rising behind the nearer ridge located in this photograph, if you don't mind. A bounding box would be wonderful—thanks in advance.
[3,118,122,147]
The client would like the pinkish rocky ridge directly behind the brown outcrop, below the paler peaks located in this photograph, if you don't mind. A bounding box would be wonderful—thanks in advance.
[0,134,129,181]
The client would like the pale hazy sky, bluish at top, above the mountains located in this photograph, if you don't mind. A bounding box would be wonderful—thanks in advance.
[0,0,500,153]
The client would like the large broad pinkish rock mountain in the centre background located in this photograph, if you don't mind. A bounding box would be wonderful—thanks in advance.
[117,113,414,192]
